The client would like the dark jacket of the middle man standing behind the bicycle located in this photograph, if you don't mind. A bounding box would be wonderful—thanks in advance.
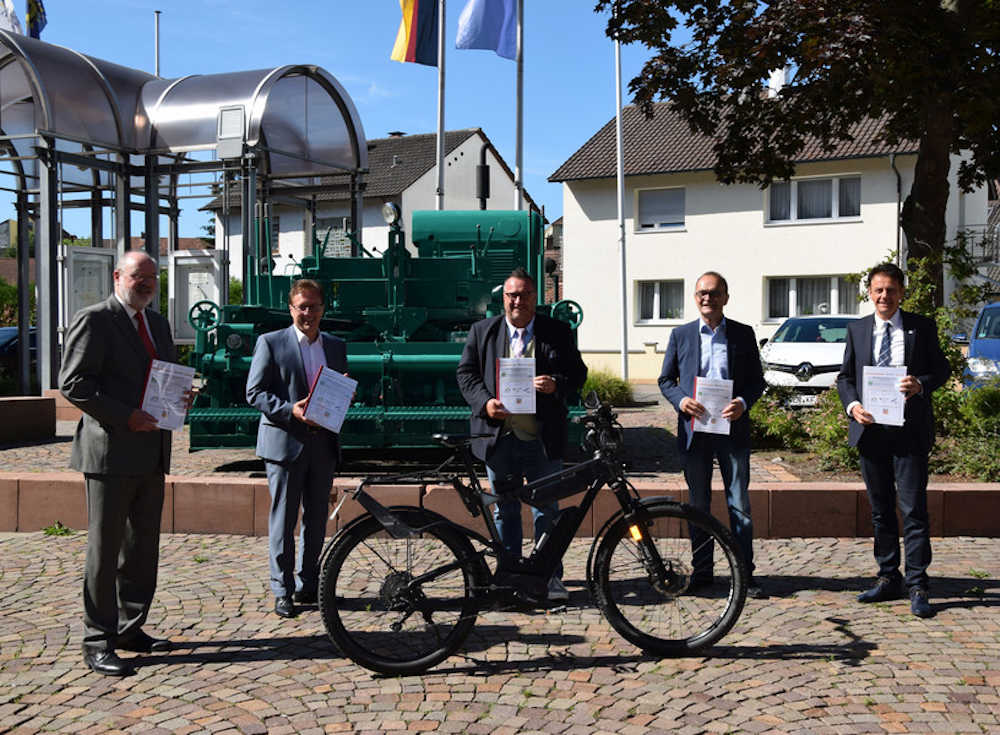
[457,314,587,460]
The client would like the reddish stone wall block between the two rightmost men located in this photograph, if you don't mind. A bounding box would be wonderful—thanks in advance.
[764,483,863,538]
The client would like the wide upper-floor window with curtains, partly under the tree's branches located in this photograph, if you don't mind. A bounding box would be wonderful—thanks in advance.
[767,176,861,222]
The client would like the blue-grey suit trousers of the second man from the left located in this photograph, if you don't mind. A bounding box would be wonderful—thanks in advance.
[265,431,337,597]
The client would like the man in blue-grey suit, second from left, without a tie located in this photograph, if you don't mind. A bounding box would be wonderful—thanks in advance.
[246,279,347,618]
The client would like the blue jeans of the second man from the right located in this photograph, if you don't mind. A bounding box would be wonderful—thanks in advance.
[681,432,754,577]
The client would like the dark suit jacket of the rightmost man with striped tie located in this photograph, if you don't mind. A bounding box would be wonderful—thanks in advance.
[837,309,951,452]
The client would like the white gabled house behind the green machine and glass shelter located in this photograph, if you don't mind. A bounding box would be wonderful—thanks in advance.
[211,128,537,278]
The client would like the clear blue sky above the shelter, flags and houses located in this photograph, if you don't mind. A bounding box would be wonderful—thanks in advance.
[3,0,660,236]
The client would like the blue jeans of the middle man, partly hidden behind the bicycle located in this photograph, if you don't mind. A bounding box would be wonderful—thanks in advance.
[486,434,562,578]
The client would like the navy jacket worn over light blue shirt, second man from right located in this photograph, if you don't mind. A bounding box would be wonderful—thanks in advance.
[657,317,767,451]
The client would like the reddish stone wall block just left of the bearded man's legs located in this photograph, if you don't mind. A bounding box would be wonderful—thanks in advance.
[17,472,87,531]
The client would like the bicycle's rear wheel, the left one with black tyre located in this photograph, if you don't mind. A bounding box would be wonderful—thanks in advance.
[319,509,488,674]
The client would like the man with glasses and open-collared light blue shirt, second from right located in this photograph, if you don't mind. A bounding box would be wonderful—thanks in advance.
[658,271,765,597]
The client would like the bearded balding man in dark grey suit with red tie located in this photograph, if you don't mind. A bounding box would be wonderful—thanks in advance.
[59,250,190,676]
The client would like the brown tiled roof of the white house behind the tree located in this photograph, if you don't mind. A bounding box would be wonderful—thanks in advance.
[549,102,916,181]
